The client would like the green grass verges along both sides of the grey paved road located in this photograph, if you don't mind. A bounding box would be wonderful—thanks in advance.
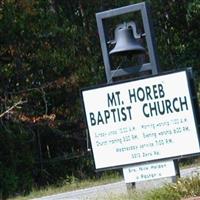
[9,162,200,200]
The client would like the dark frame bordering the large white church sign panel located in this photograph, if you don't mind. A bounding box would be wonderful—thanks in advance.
[81,68,200,171]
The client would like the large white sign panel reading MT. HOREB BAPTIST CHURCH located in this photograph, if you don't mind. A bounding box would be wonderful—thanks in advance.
[82,70,200,169]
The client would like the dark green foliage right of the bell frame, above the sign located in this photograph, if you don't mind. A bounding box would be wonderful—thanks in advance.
[150,0,199,73]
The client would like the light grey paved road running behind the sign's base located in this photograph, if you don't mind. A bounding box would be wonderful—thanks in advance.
[34,167,200,200]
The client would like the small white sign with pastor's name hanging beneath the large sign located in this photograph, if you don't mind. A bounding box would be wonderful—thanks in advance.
[123,160,176,183]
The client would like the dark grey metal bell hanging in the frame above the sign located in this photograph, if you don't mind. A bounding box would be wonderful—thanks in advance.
[109,25,145,55]
